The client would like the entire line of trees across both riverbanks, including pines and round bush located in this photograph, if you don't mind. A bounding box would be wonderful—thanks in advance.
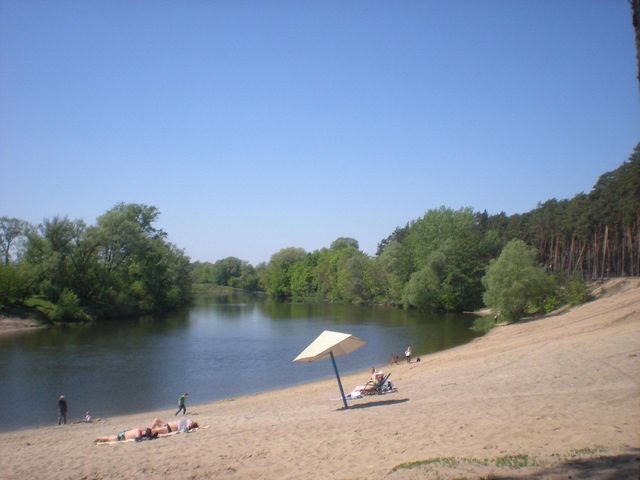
[0,144,640,320]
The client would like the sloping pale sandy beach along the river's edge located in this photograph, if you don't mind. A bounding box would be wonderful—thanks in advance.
[0,278,640,480]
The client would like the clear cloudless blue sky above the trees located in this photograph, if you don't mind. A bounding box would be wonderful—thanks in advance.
[0,0,640,265]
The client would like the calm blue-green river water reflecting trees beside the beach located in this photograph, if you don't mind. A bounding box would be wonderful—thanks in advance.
[0,294,479,431]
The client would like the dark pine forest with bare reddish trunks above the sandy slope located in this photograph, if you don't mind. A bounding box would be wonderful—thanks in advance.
[486,144,640,279]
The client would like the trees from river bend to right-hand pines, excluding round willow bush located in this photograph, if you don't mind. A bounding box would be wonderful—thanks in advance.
[194,144,640,311]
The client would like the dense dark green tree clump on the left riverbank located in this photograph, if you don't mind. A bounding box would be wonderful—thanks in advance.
[0,203,191,321]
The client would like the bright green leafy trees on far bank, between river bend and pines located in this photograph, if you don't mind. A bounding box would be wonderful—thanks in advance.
[252,208,492,311]
